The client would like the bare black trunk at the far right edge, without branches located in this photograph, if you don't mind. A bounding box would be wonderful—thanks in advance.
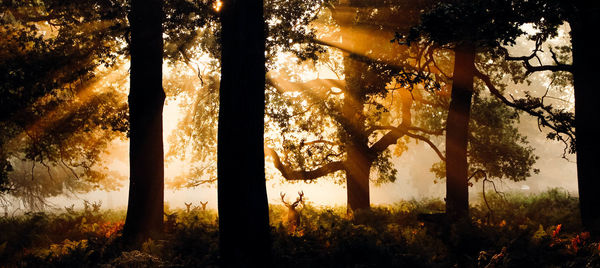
[571,0,600,237]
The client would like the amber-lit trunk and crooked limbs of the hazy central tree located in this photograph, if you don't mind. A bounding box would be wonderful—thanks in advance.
[268,1,432,212]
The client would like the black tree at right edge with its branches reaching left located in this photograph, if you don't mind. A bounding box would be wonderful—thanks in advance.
[490,1,600,236]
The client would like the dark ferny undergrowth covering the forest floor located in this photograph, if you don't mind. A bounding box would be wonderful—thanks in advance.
[0,189,600,267]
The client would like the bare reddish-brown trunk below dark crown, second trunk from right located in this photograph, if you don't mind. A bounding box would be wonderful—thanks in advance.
[446,44,475,220]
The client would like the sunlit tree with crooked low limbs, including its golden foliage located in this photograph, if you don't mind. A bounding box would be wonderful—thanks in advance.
[267,1,535,215]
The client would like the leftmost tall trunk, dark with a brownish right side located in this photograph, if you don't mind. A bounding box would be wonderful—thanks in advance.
[123,0,165,243]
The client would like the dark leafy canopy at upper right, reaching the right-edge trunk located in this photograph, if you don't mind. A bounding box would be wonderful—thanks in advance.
[404,0,577,158]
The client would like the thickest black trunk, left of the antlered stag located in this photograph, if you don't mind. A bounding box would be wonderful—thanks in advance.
[217,0,271,267]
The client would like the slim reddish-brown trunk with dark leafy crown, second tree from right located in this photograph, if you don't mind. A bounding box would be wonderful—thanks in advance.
[406,0,544,221]
